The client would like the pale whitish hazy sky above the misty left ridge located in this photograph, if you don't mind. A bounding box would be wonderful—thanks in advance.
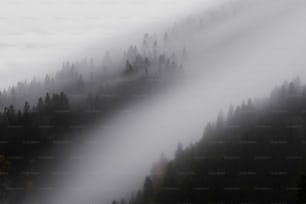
[0,0,224,88]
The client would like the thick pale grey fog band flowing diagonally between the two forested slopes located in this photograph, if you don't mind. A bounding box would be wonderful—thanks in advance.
[29,0,306,203]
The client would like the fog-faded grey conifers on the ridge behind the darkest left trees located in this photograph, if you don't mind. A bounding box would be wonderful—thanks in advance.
[0,28,187,109]
